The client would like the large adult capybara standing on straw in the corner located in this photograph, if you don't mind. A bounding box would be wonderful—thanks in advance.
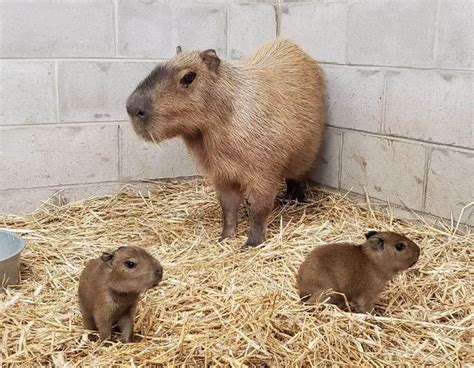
[127,39,325,246]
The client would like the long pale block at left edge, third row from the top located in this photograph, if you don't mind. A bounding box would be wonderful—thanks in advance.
[0,124,118,190]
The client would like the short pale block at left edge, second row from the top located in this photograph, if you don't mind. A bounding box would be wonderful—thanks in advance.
[0,60,56,125]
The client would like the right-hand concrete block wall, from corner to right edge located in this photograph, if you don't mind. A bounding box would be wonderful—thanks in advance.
[280,0,474,225]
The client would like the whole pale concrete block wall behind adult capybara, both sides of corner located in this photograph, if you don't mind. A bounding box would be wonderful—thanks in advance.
[0,0,474,224]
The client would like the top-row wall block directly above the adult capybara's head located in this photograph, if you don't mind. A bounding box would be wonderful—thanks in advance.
[118,0,226,58]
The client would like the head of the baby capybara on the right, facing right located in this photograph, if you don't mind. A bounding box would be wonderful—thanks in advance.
[364,231,420,273]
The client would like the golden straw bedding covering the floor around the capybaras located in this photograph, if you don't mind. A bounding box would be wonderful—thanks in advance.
[0,180,474,367]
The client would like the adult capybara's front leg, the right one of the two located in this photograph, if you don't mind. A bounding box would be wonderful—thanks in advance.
[244,190,276,247]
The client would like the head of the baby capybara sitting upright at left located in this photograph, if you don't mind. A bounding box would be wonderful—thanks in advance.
[100,246,163,294]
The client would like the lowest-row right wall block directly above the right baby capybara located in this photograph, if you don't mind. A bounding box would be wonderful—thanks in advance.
[341,131,425,210]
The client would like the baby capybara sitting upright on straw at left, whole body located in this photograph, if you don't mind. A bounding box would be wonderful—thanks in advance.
[79,246,163,342]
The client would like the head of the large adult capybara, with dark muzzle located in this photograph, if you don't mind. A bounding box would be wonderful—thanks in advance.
[126,46,223,142]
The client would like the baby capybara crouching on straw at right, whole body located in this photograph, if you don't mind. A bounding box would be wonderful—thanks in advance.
[297,231,420,312]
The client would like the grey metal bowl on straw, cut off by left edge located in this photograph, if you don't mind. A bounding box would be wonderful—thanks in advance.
[0,230,25,289]
